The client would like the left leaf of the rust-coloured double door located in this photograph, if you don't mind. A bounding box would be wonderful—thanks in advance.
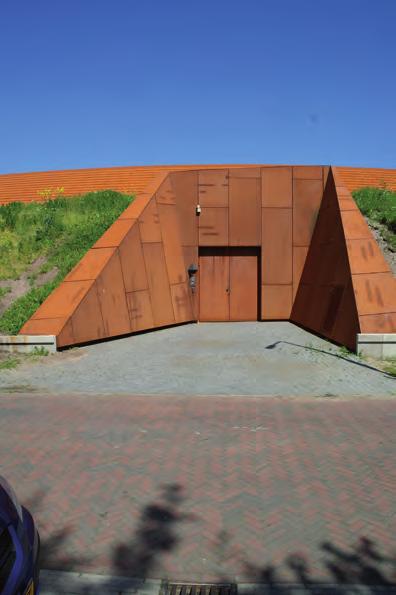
[199,249,230,321]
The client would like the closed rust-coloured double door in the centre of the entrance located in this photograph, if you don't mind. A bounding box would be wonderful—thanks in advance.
[199,247,259,322]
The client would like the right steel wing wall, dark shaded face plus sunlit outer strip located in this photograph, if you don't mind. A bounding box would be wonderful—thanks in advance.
[291,169,396,349]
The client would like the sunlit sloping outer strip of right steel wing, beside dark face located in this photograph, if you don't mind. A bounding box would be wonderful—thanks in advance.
[332,167,396,334]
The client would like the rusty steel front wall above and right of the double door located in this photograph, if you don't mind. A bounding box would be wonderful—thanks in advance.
[170,166,328,320]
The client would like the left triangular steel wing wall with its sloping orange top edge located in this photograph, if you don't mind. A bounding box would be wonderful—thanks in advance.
[21,172,194,347]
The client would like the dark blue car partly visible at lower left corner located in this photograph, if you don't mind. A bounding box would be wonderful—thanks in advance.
[0,476,40,595]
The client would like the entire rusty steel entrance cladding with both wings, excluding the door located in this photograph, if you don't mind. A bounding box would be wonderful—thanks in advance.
[17,166,396,348]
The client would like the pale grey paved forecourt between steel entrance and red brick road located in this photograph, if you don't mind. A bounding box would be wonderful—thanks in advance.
[0,322,396,397]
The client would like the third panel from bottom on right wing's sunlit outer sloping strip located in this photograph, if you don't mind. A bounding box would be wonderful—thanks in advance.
[346,238,390,276]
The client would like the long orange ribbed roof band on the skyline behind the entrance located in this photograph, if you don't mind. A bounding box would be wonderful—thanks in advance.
[0,164,396,204]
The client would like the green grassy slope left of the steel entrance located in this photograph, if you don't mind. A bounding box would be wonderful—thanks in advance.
[0,190,133,334]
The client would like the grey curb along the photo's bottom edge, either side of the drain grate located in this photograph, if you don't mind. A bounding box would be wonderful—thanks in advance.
[40,570,396,595]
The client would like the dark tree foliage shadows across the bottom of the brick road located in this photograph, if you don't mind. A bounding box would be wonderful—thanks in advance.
[34,484,396,595]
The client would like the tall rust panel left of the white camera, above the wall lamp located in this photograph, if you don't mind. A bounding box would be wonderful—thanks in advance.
[170,171,199,246]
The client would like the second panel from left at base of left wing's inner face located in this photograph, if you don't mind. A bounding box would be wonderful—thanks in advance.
[71,283,108,343]
